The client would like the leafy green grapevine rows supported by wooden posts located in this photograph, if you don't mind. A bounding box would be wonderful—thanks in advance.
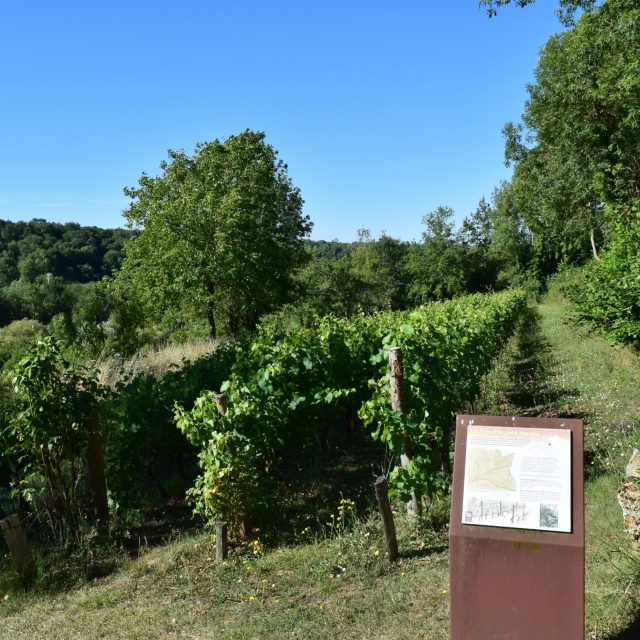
[3,291,525,545]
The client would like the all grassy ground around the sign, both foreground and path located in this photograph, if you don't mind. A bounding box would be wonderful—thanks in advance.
[0,297,640,640]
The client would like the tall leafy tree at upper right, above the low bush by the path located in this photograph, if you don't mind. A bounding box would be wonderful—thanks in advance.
[505,0,640,268]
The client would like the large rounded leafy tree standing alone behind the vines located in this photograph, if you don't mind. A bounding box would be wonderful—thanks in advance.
[116,130,312,338]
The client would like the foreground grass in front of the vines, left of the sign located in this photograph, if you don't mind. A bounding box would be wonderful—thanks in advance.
[0,510,448,640]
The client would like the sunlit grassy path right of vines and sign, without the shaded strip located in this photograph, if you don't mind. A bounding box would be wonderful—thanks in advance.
[540,296,640,640]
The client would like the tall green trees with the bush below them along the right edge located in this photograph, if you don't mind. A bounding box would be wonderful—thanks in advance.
[498,0,640,344]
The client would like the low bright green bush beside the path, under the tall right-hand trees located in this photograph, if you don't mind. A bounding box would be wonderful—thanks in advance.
[567,204,640,345]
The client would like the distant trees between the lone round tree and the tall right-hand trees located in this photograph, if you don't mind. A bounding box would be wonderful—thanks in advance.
[300,192,528,317]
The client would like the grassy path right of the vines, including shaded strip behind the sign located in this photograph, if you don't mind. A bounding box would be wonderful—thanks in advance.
[478,294,640,640]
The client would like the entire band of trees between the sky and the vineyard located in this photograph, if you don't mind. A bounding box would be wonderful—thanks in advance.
[5,0,640,353]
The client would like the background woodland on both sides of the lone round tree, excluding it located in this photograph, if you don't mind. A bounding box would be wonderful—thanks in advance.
[0,188,538,360]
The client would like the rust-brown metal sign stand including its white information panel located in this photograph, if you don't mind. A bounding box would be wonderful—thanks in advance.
[449,415,584,640]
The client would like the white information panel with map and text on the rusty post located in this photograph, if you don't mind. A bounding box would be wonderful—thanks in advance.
[462,424,571,532]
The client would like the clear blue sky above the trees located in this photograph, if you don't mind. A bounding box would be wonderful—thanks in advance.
[0,0,561,241]
